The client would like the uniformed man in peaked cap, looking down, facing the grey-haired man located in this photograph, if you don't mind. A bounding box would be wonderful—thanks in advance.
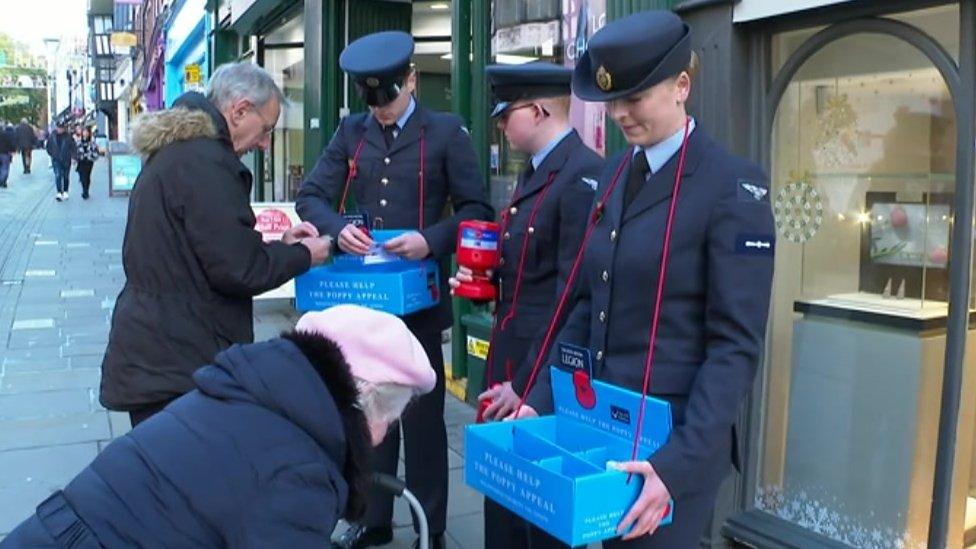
[296,31,493,548]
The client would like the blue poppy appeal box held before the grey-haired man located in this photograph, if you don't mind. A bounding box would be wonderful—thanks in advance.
[295,231,440,316]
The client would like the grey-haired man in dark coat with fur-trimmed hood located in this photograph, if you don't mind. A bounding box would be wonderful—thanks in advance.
[99,63,330,425]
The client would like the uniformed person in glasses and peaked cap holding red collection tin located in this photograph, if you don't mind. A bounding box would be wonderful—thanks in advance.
[451,63,603,549]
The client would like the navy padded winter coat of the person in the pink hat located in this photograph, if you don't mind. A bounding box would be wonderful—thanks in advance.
[0,335,370,549]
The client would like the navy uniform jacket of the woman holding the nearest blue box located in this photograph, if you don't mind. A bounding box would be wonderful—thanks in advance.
[529,128,774,499]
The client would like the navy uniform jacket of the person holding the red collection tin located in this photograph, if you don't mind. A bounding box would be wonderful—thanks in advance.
[485,130,603,394]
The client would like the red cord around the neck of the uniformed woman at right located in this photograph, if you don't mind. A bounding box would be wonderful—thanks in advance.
[515,118,690,480]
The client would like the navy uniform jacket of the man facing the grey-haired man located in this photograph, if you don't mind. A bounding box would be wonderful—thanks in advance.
[295,104,492,332]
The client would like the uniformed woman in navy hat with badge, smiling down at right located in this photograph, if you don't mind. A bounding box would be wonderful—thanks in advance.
[518,11,774,549]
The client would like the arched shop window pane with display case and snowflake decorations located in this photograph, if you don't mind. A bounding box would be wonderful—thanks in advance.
[756,34,956,548]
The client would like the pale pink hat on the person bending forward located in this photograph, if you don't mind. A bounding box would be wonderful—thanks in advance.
[295,305,437,393]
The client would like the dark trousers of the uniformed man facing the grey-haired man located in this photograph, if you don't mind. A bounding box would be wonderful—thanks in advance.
[362,331,447,535]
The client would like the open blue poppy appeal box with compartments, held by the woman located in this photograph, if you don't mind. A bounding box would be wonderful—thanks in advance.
[464,367,674,546]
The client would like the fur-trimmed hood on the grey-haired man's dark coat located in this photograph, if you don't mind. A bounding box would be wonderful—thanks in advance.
[131,92,230,156]
